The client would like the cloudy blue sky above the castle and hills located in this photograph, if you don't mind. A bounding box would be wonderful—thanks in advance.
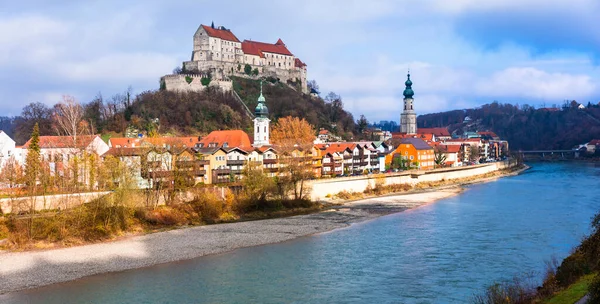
[0,0,600,121]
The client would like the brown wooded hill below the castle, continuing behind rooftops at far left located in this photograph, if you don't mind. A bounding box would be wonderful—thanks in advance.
[5,77,355,144]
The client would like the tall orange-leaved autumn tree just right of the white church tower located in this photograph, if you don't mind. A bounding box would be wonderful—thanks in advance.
[271,116,315,200]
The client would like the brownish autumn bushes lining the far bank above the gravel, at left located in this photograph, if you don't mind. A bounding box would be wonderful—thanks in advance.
[0,188,322,250]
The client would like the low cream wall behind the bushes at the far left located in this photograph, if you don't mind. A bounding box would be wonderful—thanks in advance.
[0,191,110,213]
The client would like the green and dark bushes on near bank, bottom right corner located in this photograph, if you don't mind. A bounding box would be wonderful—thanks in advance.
[471,213,600,304]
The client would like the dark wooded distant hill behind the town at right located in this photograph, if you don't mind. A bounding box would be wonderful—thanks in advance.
[417,102,600,150]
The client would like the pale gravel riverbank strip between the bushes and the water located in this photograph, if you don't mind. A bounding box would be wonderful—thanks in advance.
[0,164,514,294]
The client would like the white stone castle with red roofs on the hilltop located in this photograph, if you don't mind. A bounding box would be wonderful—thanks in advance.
[161,25,308,93]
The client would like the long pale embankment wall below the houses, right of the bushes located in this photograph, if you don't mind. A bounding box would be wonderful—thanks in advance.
[309,161,516,200]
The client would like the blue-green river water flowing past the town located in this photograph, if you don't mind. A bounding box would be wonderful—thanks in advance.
[0,163,600,303]
